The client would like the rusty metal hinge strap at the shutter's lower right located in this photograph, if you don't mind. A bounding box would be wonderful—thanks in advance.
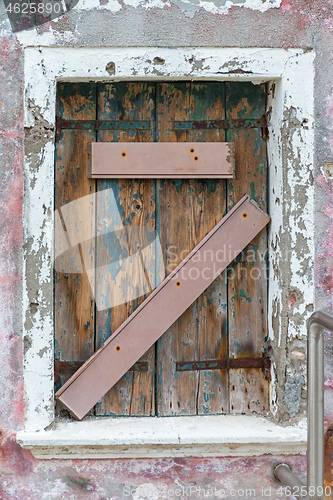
[176,355,271,379]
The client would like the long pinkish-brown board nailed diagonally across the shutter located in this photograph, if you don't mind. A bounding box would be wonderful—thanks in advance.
[56,195,270,419]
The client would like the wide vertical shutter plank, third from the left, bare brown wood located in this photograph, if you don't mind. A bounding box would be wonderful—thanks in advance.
[157,83,228,415]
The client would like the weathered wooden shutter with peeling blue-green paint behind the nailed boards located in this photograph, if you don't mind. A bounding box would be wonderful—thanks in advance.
[55,82,268,415]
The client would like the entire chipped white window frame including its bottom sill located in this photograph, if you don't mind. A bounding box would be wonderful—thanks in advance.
[17,46,314,458]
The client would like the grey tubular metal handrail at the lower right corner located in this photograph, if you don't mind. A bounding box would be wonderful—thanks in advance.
[274,311,333,500]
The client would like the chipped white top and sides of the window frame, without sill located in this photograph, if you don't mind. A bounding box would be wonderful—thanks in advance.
[24,46,314,446]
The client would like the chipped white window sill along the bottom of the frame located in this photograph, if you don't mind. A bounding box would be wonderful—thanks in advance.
[17,415,306,459]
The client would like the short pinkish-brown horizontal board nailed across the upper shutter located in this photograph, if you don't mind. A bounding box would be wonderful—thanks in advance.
[88,142,235,179]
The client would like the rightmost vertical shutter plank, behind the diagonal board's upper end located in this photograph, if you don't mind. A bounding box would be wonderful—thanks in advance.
[226,83,269,414]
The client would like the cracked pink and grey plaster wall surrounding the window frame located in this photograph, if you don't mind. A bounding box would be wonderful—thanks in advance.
[0,0,333,499]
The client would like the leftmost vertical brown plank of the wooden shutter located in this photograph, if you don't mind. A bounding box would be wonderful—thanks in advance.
[54,83,96,402]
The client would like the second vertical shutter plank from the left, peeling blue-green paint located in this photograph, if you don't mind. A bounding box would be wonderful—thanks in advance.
[95,82,156,415]
